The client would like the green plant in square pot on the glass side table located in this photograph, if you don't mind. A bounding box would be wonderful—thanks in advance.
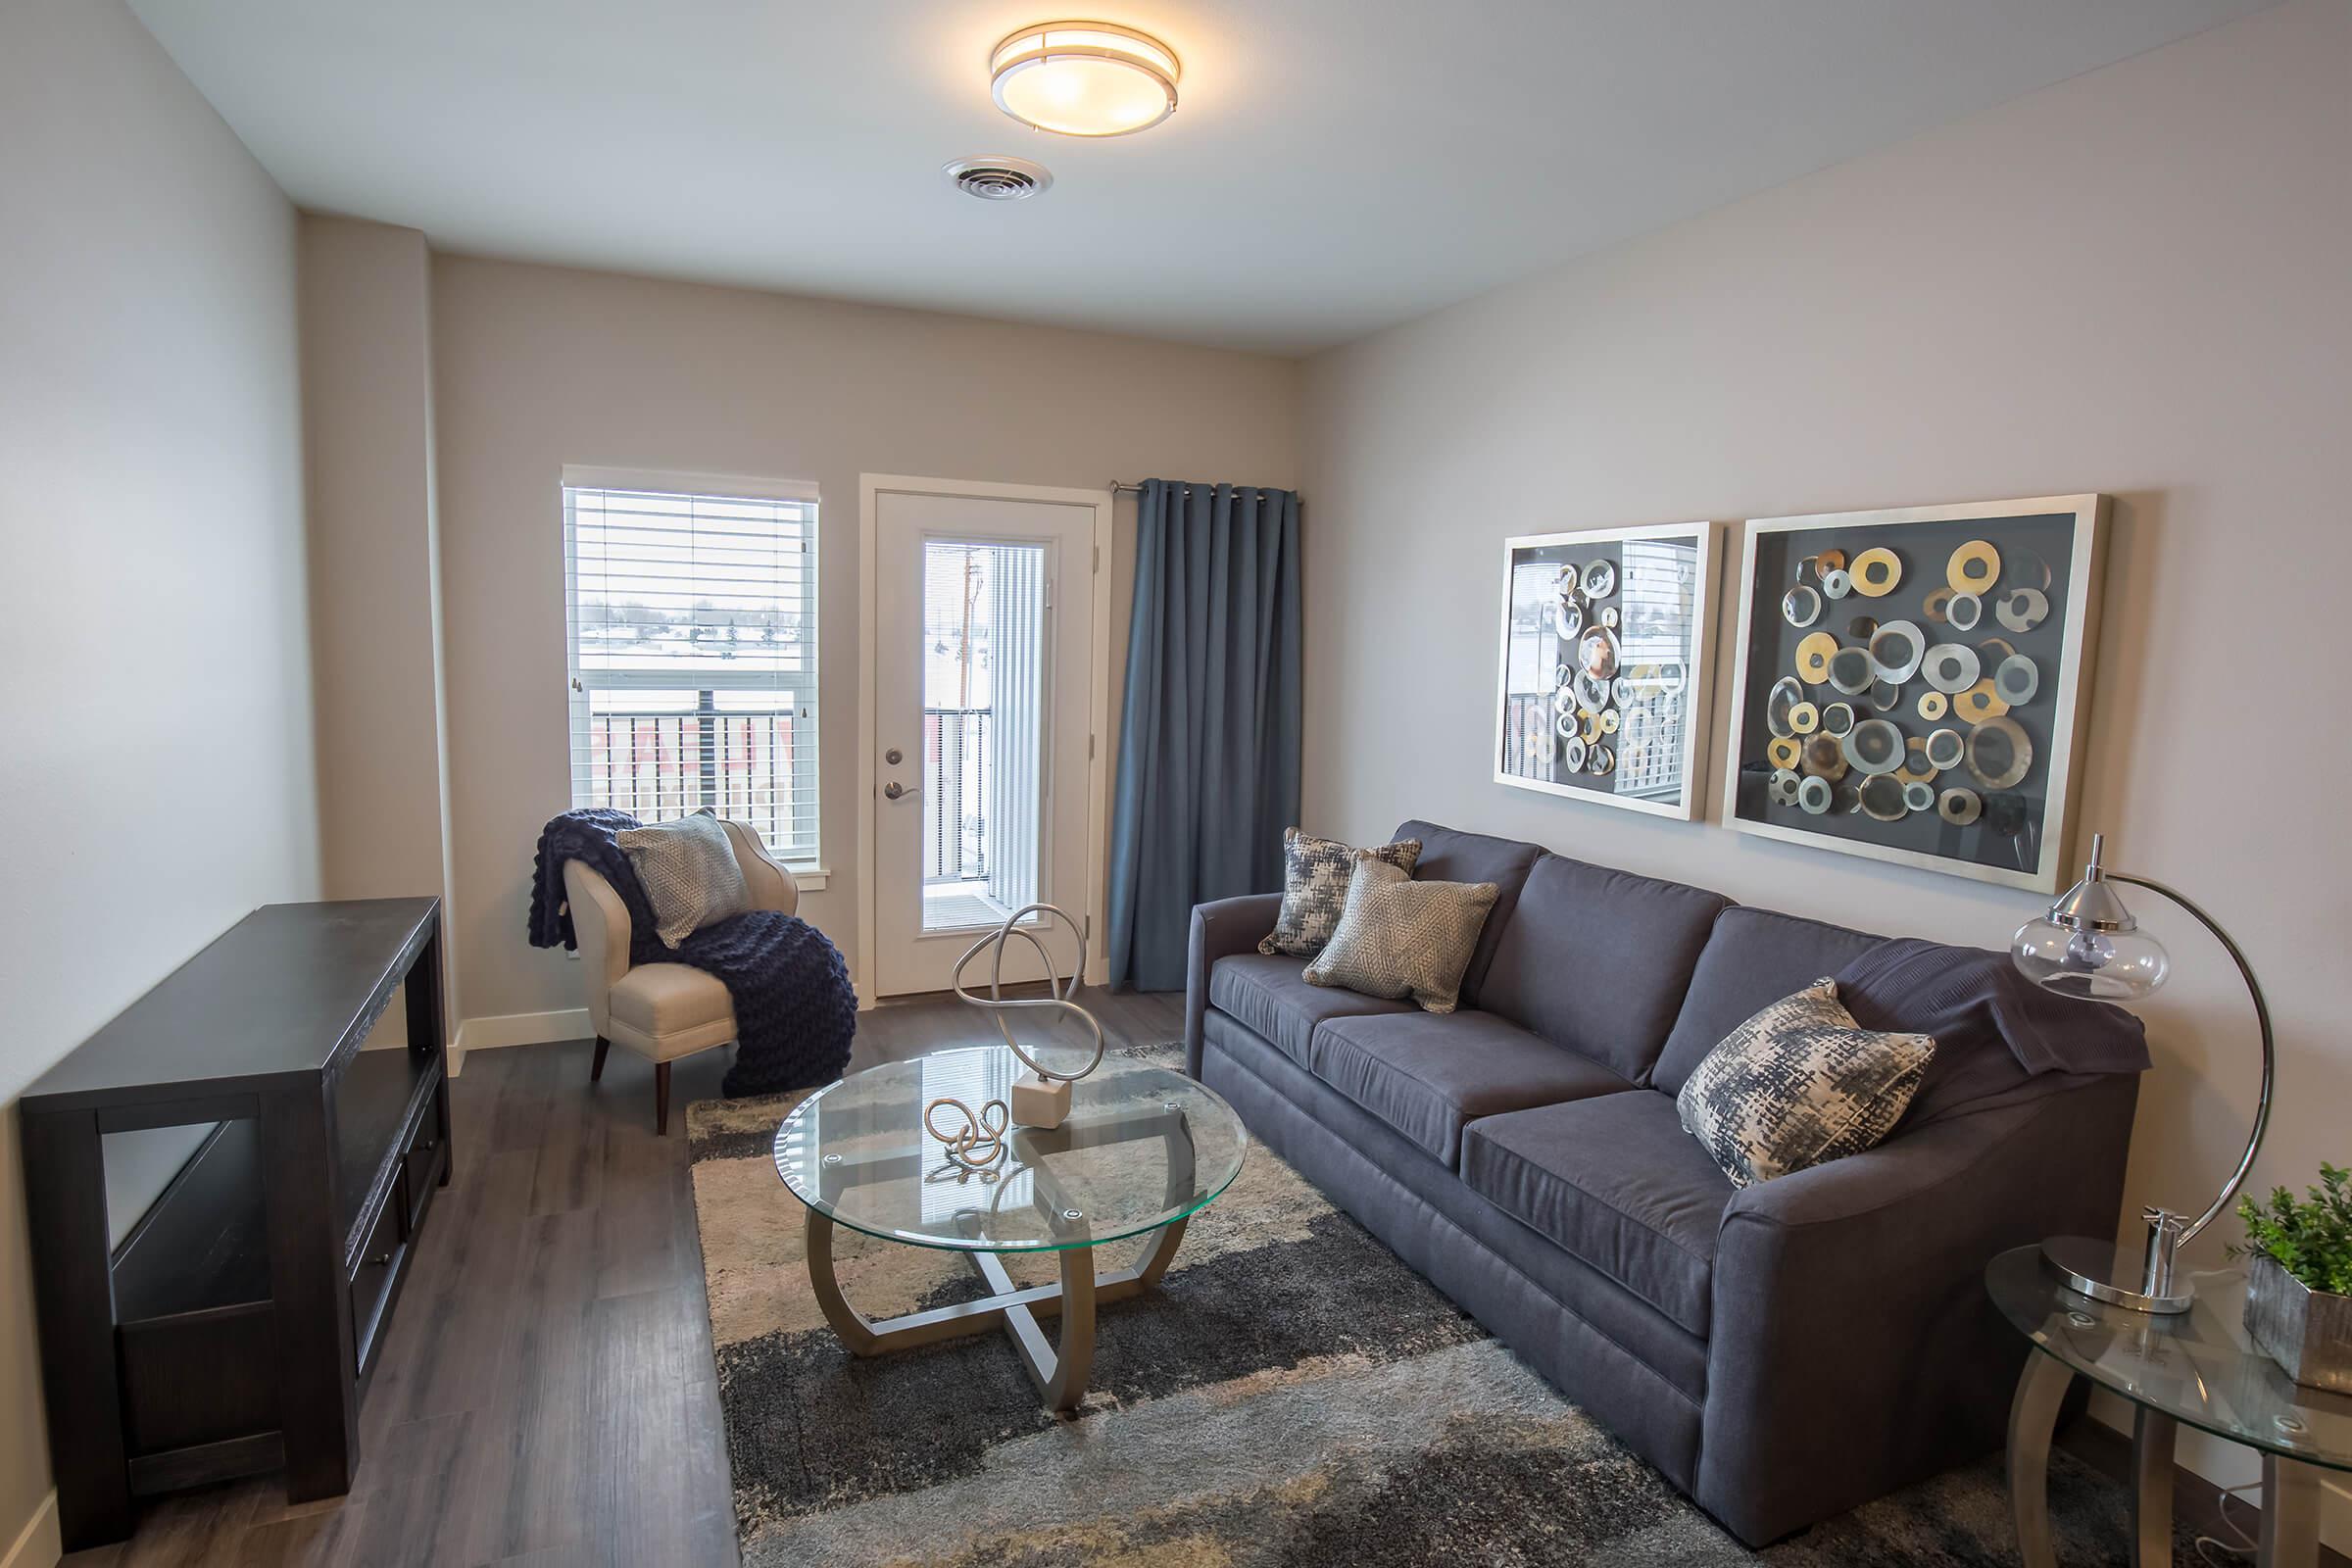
[2236,1163,2352,1394]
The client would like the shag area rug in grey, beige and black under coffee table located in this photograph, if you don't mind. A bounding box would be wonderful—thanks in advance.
[687,1046,2199,1568]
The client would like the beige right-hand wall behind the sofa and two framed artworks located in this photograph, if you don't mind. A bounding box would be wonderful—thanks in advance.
[1305,0,2352,1523]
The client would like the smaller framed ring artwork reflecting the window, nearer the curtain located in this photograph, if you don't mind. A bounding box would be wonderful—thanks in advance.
[1494,522,1719,820]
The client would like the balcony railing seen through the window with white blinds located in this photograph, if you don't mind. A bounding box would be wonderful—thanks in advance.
[574,691,816,858]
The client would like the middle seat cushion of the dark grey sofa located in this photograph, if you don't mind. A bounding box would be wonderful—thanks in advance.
[1307,1013,1633,1166]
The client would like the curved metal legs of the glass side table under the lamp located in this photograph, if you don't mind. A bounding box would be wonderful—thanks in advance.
[2009,1349,2319,1568]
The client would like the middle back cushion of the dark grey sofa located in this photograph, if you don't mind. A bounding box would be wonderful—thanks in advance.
[1480,856,1731,1081]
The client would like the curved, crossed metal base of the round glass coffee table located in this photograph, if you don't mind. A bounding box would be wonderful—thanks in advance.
[809,1208,1185,1419]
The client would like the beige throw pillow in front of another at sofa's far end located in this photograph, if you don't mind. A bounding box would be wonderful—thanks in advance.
[1307,849,1495,1013]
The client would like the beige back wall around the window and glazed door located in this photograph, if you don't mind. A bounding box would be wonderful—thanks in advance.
[433,256,1298,1018]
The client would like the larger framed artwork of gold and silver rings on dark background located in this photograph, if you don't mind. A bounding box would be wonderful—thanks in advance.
[1722,496,2107,894]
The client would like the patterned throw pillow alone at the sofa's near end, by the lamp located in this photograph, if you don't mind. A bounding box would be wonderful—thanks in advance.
[1675,980,1936,1187]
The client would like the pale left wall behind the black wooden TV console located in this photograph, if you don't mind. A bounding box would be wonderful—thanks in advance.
[0,0,318,1563]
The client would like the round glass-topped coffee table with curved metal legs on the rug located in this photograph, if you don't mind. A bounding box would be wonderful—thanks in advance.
[776,1046,1249,1410]
